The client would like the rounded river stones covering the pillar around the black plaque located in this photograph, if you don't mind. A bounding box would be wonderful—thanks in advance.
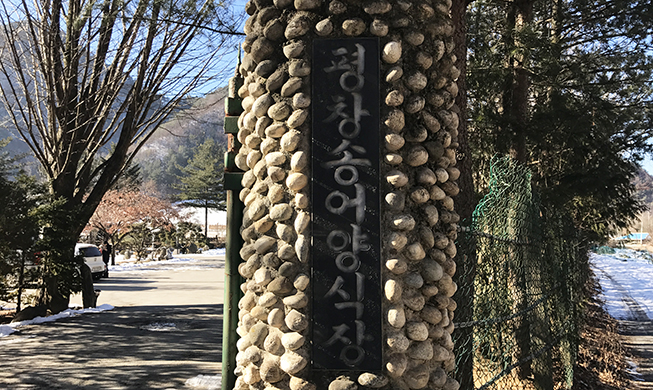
[235,0,460,390]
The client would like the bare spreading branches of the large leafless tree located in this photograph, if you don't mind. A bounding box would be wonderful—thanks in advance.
[0,0,241,234]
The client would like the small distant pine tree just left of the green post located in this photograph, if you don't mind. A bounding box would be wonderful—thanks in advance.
[178,138,226,236]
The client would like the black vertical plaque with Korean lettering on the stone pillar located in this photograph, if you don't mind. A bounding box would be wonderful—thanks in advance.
[312,38,382,371]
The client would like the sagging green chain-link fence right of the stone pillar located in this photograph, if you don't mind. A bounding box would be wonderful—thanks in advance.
[454,158,588,390]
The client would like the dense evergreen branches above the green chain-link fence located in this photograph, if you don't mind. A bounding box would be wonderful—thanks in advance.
[467,0,653,238]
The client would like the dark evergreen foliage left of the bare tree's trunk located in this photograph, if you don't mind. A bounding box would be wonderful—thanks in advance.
[0,142,82,311]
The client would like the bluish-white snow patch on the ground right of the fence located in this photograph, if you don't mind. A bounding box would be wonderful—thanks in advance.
[590,249,653,319]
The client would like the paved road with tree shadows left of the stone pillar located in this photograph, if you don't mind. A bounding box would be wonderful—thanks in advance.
[0,257,224,389]
